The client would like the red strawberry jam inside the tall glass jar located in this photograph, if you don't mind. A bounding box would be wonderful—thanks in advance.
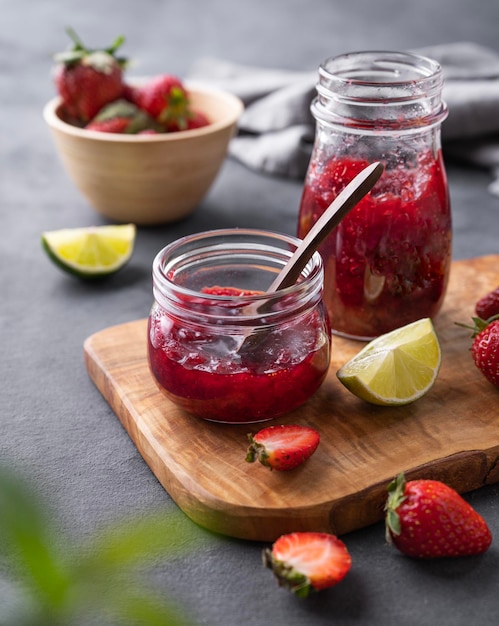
[298,151,451,339]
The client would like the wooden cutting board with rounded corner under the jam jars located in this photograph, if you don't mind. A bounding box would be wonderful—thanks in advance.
[84,255,499,541]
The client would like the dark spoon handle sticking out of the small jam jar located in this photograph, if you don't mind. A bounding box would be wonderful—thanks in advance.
[267,162,384,293]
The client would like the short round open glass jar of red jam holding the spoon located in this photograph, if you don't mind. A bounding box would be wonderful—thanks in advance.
[148,229,331,424]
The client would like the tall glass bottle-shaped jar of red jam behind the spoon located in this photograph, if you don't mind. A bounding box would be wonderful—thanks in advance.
[298,52,452,339]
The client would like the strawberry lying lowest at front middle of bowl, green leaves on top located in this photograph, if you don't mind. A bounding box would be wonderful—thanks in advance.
[85,99,161,135]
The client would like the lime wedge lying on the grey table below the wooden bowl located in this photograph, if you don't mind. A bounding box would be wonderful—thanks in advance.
[42,224,136,278]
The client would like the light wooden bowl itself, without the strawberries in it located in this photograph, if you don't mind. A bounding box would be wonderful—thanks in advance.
[43,82,243,225]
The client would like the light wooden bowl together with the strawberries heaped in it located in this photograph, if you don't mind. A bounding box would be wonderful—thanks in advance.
[43,29,243,226]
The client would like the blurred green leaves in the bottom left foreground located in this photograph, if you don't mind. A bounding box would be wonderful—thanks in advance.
[0,467,203,626]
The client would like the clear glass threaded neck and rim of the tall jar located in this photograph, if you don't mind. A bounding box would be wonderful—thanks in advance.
[311,50,448,134]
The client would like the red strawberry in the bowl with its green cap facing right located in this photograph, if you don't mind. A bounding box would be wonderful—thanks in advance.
[127,74,188,130]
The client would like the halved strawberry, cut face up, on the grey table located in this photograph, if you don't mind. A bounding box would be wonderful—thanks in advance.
[263,532,352,598]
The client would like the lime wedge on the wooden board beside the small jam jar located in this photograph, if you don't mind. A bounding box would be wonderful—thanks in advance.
[336,318,442,406]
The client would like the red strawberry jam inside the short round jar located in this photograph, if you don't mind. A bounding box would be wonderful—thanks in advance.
[148,286,330,423]
